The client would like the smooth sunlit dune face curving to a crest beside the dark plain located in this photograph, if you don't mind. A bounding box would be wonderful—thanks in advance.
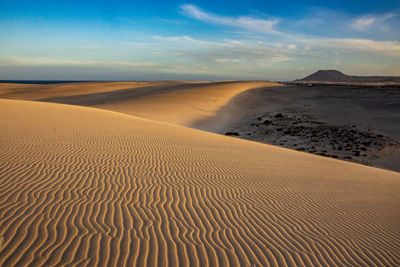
[95,81,278,126]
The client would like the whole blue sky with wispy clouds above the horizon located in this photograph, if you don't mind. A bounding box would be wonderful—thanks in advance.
[0,0,400,81]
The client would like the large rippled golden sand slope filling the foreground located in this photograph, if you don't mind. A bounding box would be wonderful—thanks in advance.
[0,100,400,266]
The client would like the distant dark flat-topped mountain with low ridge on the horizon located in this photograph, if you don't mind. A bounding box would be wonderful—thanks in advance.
[296,70,400,83]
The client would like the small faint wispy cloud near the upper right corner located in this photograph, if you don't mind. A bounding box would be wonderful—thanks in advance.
[350,13,396,32]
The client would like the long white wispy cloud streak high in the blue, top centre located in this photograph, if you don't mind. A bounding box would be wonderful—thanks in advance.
[180,4,281,34]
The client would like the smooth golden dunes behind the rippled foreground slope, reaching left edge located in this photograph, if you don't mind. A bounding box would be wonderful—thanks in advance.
[0,81,279,126]
